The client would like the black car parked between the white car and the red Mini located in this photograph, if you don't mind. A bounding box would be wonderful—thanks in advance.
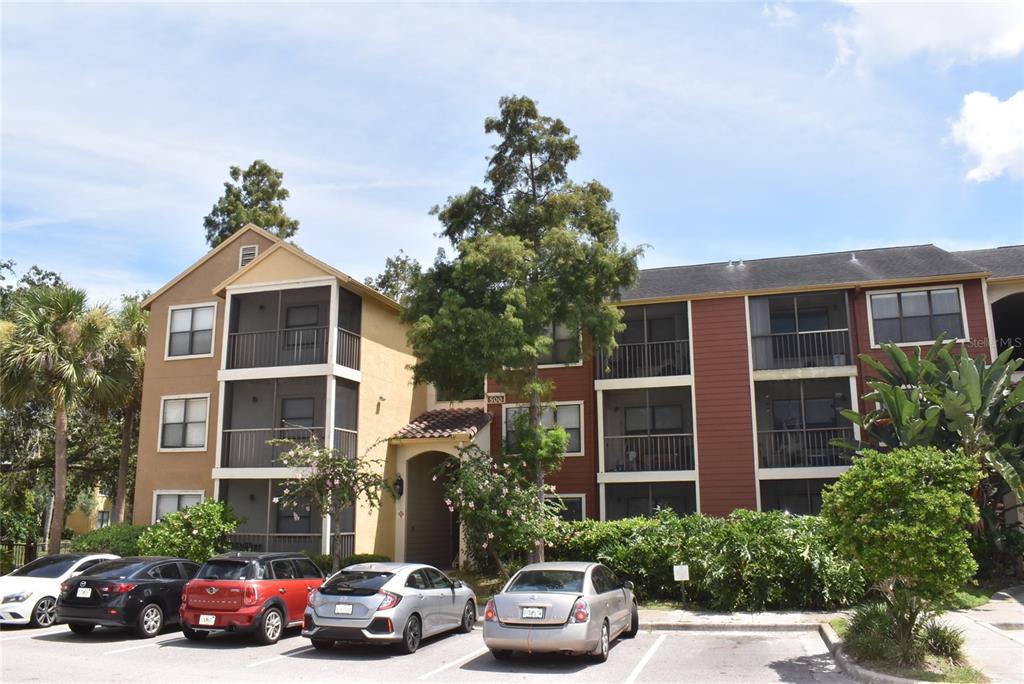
[57,556,199,638]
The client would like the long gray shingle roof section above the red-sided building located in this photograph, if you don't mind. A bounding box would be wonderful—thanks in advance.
[623,245,988,301]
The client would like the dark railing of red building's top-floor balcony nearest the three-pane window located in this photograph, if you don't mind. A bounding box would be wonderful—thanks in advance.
[753,328,853,371]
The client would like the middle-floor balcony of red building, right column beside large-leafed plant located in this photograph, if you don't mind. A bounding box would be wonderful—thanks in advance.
[755,378,854,468]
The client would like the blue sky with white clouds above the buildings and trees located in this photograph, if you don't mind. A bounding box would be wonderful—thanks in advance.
[0,2,1024,301]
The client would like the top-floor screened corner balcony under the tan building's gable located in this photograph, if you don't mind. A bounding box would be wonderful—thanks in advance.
[225,287,361,369]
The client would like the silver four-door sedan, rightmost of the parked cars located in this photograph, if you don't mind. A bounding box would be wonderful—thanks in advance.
[483,562,640,662]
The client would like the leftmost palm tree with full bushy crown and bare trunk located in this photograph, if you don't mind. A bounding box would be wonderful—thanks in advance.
[0,286,122,553]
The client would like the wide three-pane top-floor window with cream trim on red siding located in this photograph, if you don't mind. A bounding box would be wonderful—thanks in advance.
[871,288,964,344]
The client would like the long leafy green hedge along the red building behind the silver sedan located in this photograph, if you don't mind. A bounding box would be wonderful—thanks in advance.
[547,510,865,610]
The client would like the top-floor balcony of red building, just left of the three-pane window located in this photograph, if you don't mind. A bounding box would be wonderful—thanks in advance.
[751,292,854,371]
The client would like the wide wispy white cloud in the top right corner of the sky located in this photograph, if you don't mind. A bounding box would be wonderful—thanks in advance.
[828,2,1024,68]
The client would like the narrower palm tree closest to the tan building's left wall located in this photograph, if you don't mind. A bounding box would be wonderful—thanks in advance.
[111,297,150,523]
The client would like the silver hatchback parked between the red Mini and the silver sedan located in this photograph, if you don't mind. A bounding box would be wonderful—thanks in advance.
[302,563,476,653]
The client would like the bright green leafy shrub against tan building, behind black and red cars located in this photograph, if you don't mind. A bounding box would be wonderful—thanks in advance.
[138,500,238,563]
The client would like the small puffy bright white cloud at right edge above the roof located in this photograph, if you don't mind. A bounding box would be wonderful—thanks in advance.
[950,90,1024,183]
